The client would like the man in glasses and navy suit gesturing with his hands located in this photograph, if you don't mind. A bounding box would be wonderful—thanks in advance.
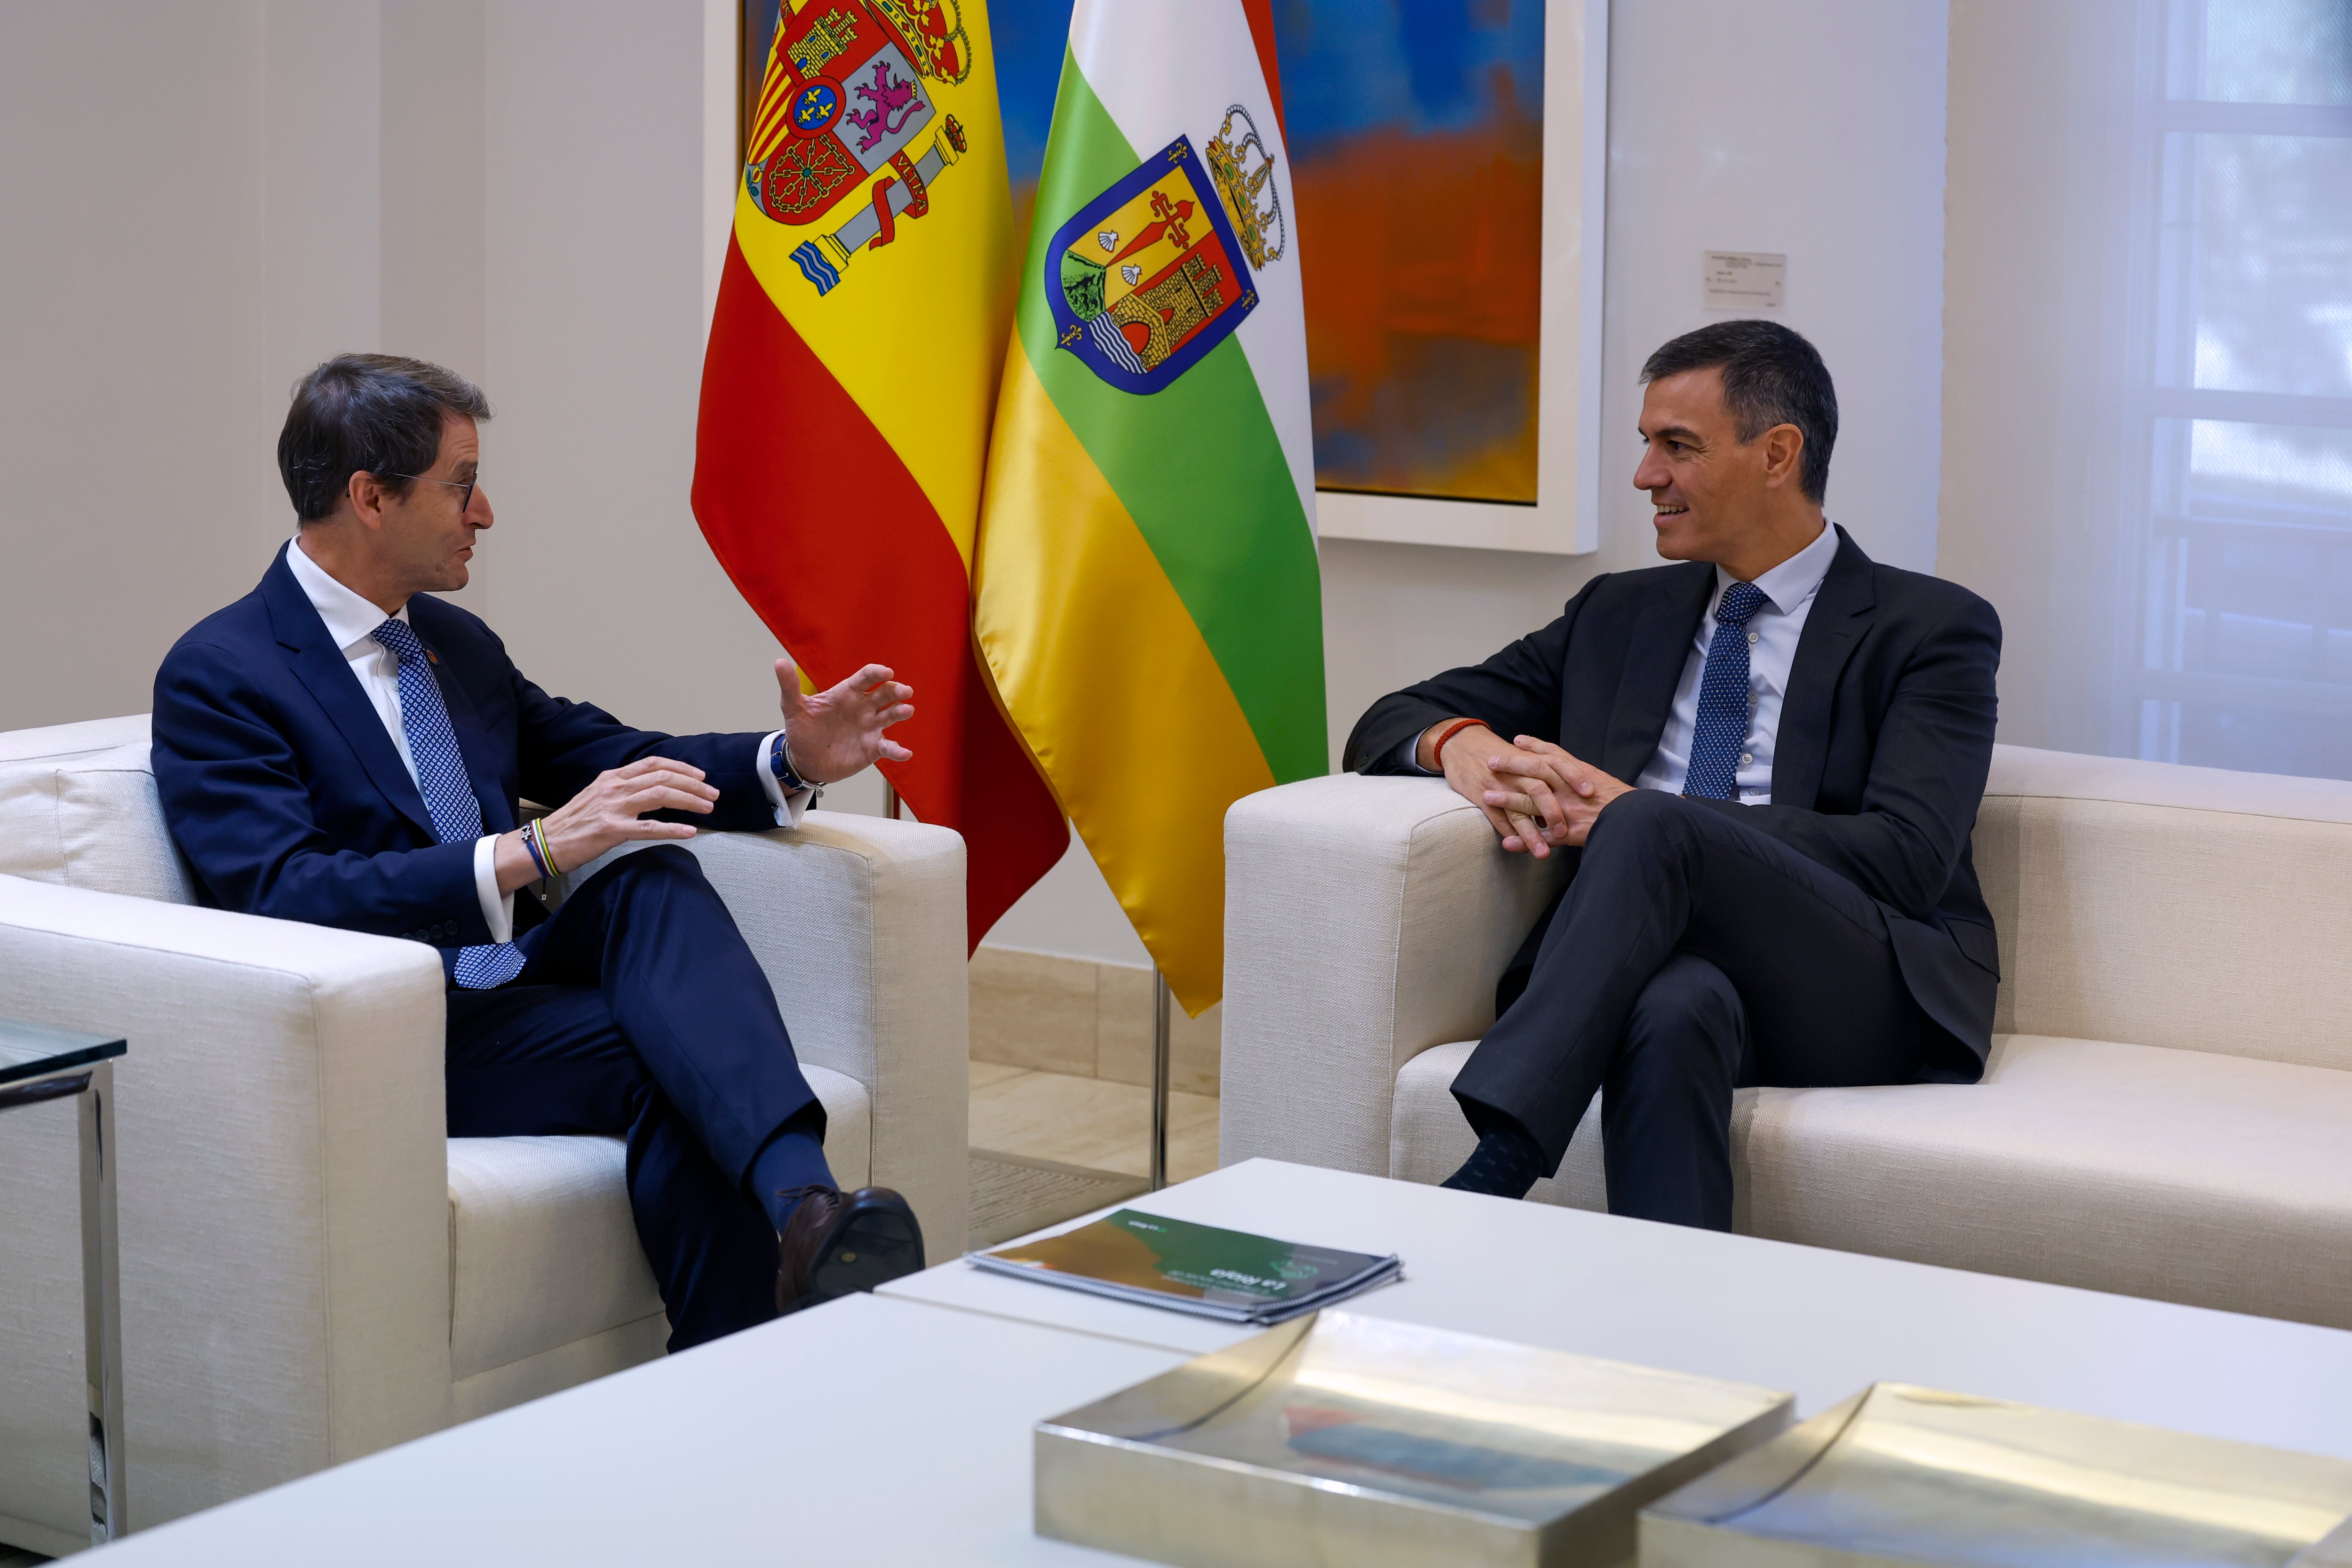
[153,355,922,1349]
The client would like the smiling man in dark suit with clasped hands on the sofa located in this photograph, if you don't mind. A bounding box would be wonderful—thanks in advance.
[1348,322,2002,1229]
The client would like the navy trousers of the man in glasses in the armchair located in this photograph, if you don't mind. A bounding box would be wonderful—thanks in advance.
[449,844,823,1352]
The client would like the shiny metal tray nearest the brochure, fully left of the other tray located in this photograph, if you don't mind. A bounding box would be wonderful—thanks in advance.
[1035,1309,1792,1568]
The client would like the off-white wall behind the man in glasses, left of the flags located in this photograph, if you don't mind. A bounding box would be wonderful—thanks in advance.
[0,0,898,806]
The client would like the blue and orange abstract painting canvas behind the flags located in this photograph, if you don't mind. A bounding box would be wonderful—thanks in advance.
[1275,0,1543,503]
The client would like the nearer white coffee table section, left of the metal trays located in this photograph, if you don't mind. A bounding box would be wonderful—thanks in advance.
[94,1295,1185,1568]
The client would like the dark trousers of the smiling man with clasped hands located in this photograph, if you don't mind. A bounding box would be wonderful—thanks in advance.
[1454,790,1936,1229]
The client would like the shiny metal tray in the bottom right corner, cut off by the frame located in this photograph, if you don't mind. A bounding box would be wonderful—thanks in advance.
[1642,1382,2352,1568]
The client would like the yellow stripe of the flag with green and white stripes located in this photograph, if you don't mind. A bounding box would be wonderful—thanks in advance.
[974,343,1275,1016]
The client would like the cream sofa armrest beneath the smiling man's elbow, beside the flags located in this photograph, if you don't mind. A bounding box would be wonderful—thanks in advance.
[1218,773,1566,1176]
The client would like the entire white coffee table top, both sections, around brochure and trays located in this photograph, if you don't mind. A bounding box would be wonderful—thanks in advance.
[83,1162,2352,1568]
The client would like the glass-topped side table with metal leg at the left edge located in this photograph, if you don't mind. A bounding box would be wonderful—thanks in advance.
[0,1018,125,1547]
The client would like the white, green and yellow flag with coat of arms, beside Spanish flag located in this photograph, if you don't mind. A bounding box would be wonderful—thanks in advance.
[974,0,1329,1013]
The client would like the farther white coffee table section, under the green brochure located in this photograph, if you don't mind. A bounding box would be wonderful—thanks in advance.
[884,1159,2352,1460]
